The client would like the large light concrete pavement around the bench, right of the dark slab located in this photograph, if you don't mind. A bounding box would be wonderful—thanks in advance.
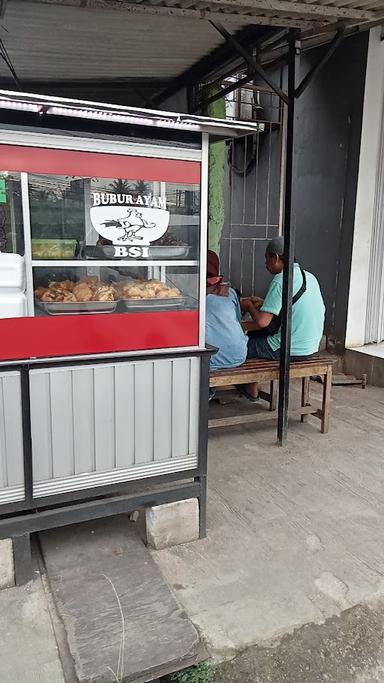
[153,383,384,668]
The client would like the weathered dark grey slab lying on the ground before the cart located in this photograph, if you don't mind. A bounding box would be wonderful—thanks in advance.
[40,516,205,683]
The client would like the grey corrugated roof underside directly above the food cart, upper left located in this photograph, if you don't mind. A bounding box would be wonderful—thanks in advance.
[0,0,248,81]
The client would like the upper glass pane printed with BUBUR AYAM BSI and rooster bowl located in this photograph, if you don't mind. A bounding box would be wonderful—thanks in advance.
[29,174,200,260]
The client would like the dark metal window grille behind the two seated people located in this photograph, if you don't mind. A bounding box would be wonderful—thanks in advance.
[221,84,285,295]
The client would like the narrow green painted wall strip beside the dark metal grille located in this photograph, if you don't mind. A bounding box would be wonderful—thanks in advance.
[207,99,225,254]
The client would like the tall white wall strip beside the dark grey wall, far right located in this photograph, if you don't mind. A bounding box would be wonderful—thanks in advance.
[345,27,384,348]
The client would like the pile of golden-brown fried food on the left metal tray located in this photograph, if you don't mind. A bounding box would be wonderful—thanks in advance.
[35,276,117,303]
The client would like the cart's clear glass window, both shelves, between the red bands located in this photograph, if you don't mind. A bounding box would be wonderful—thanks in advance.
[28,174,200,315]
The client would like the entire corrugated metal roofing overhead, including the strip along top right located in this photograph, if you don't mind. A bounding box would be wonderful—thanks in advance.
[0,0,384,87]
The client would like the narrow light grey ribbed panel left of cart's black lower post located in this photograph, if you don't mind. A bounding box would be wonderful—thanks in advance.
[0,372,24,503]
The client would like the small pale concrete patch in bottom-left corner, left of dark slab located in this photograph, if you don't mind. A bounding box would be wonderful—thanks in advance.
[0,572,64,683]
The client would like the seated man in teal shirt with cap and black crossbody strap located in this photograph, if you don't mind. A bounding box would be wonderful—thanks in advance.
[241,237,325,400]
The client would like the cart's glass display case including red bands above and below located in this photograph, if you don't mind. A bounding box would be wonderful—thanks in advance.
[0,142,204,357]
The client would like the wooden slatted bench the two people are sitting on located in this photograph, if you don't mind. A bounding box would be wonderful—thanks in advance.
[208,356,333,434]
